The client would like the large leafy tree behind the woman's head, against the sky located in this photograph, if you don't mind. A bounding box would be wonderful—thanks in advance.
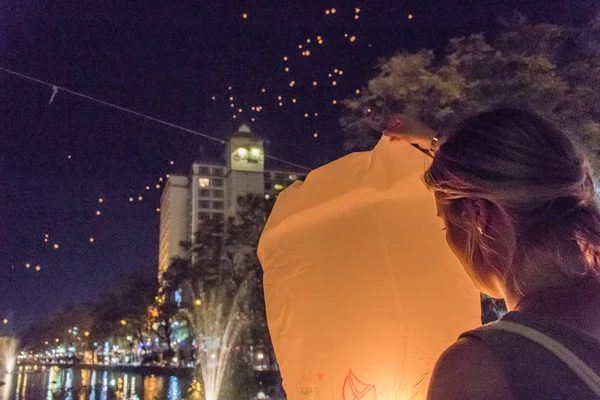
[341,15,600,170]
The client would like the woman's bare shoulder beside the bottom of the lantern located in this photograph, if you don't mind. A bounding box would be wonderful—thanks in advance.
[427,337,513,400]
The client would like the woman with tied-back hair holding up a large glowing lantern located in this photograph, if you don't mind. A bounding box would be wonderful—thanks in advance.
[384,109,600,400]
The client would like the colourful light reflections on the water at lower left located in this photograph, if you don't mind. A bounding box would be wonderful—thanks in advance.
[0,367,190,400]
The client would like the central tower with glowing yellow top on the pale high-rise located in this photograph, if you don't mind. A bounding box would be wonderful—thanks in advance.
[225,125,265,216]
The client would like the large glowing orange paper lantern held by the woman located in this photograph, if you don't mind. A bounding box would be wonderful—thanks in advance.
[258,138,480,400]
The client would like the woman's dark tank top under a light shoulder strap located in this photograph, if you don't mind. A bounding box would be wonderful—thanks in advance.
[461,312,600,400]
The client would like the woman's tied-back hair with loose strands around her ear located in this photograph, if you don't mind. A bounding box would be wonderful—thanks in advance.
[424,109,600,293]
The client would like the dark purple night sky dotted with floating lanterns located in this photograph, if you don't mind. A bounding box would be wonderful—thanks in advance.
[0,0,600,335]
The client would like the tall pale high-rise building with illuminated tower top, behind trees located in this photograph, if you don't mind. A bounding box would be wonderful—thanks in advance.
[159,125,307,280]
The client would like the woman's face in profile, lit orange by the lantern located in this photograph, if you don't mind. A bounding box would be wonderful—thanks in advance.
[436,199,503,298]
